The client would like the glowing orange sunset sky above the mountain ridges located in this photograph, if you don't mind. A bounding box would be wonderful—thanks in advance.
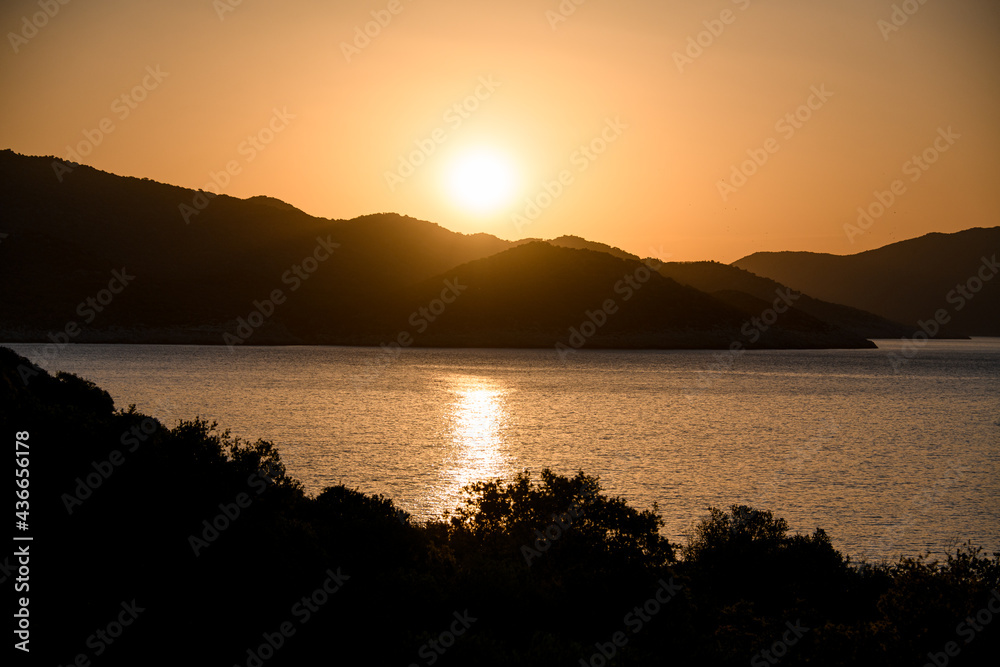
[0,0,1000,262]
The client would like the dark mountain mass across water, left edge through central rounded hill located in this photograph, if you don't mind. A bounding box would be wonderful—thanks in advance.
[0,150,888,348]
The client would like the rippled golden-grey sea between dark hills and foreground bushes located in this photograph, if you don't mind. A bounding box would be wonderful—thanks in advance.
[8,338,1000,561]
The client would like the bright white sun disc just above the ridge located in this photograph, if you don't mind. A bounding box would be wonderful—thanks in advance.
[448,148,517,213]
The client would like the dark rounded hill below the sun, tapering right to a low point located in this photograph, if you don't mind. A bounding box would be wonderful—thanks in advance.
[350,242,870,349]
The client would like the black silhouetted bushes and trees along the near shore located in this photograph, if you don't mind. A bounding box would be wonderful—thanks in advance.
[0,348,1000,667]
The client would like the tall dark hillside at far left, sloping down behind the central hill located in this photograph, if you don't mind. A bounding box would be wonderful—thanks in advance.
[0,151,510,343]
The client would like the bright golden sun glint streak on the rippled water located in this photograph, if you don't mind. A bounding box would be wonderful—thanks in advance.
[432,376,513,512]
